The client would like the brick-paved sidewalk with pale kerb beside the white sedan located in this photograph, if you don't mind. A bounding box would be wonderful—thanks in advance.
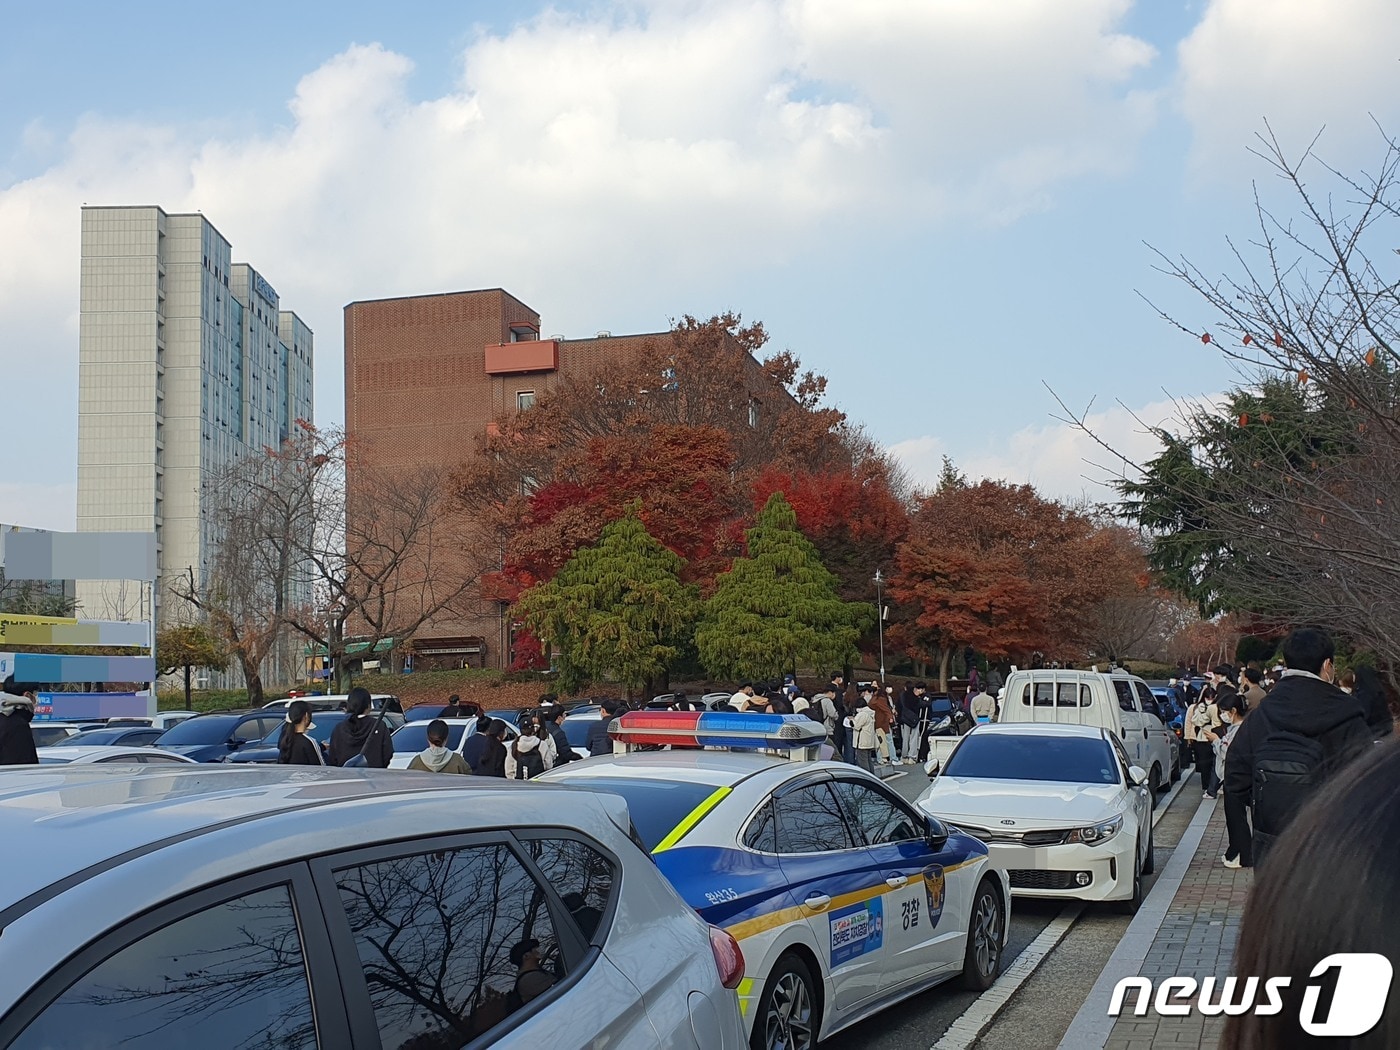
[1061,799,1253,1050]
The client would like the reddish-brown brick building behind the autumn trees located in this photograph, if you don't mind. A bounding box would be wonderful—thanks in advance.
[344,288,787,668]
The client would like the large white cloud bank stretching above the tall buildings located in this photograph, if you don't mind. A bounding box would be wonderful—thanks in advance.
[0,0,1154,466]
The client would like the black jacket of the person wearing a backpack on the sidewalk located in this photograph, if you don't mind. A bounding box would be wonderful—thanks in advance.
[1224,675,1373,857]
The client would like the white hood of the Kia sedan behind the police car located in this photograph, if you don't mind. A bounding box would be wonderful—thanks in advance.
[918,777,1124,830]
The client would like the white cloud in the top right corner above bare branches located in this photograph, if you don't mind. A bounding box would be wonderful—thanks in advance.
[1179,0,1400,165]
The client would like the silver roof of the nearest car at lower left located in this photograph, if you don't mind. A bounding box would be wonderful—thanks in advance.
[0,767,627,928]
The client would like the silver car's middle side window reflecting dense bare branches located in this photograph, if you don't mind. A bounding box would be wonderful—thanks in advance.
[335,844,564,1047]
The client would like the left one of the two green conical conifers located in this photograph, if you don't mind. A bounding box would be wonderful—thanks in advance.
[517,503,697,693]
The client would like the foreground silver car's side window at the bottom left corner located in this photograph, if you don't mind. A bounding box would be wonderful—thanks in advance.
[10,886,316,1050]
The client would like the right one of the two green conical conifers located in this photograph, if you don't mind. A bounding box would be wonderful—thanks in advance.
[696,493,874,679]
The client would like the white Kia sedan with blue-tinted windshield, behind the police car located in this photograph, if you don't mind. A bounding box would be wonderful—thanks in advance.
[918,724,1152,914]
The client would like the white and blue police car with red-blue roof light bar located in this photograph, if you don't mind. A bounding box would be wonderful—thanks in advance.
[540,711,1011,1050]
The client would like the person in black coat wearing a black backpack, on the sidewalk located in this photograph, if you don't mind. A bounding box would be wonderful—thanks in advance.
[1225,627,1375,867]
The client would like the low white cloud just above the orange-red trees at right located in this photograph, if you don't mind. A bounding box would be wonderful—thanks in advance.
[889,396,1215,503]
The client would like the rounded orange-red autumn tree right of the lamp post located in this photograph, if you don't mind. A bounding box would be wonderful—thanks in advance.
[890,472,1107,689]
